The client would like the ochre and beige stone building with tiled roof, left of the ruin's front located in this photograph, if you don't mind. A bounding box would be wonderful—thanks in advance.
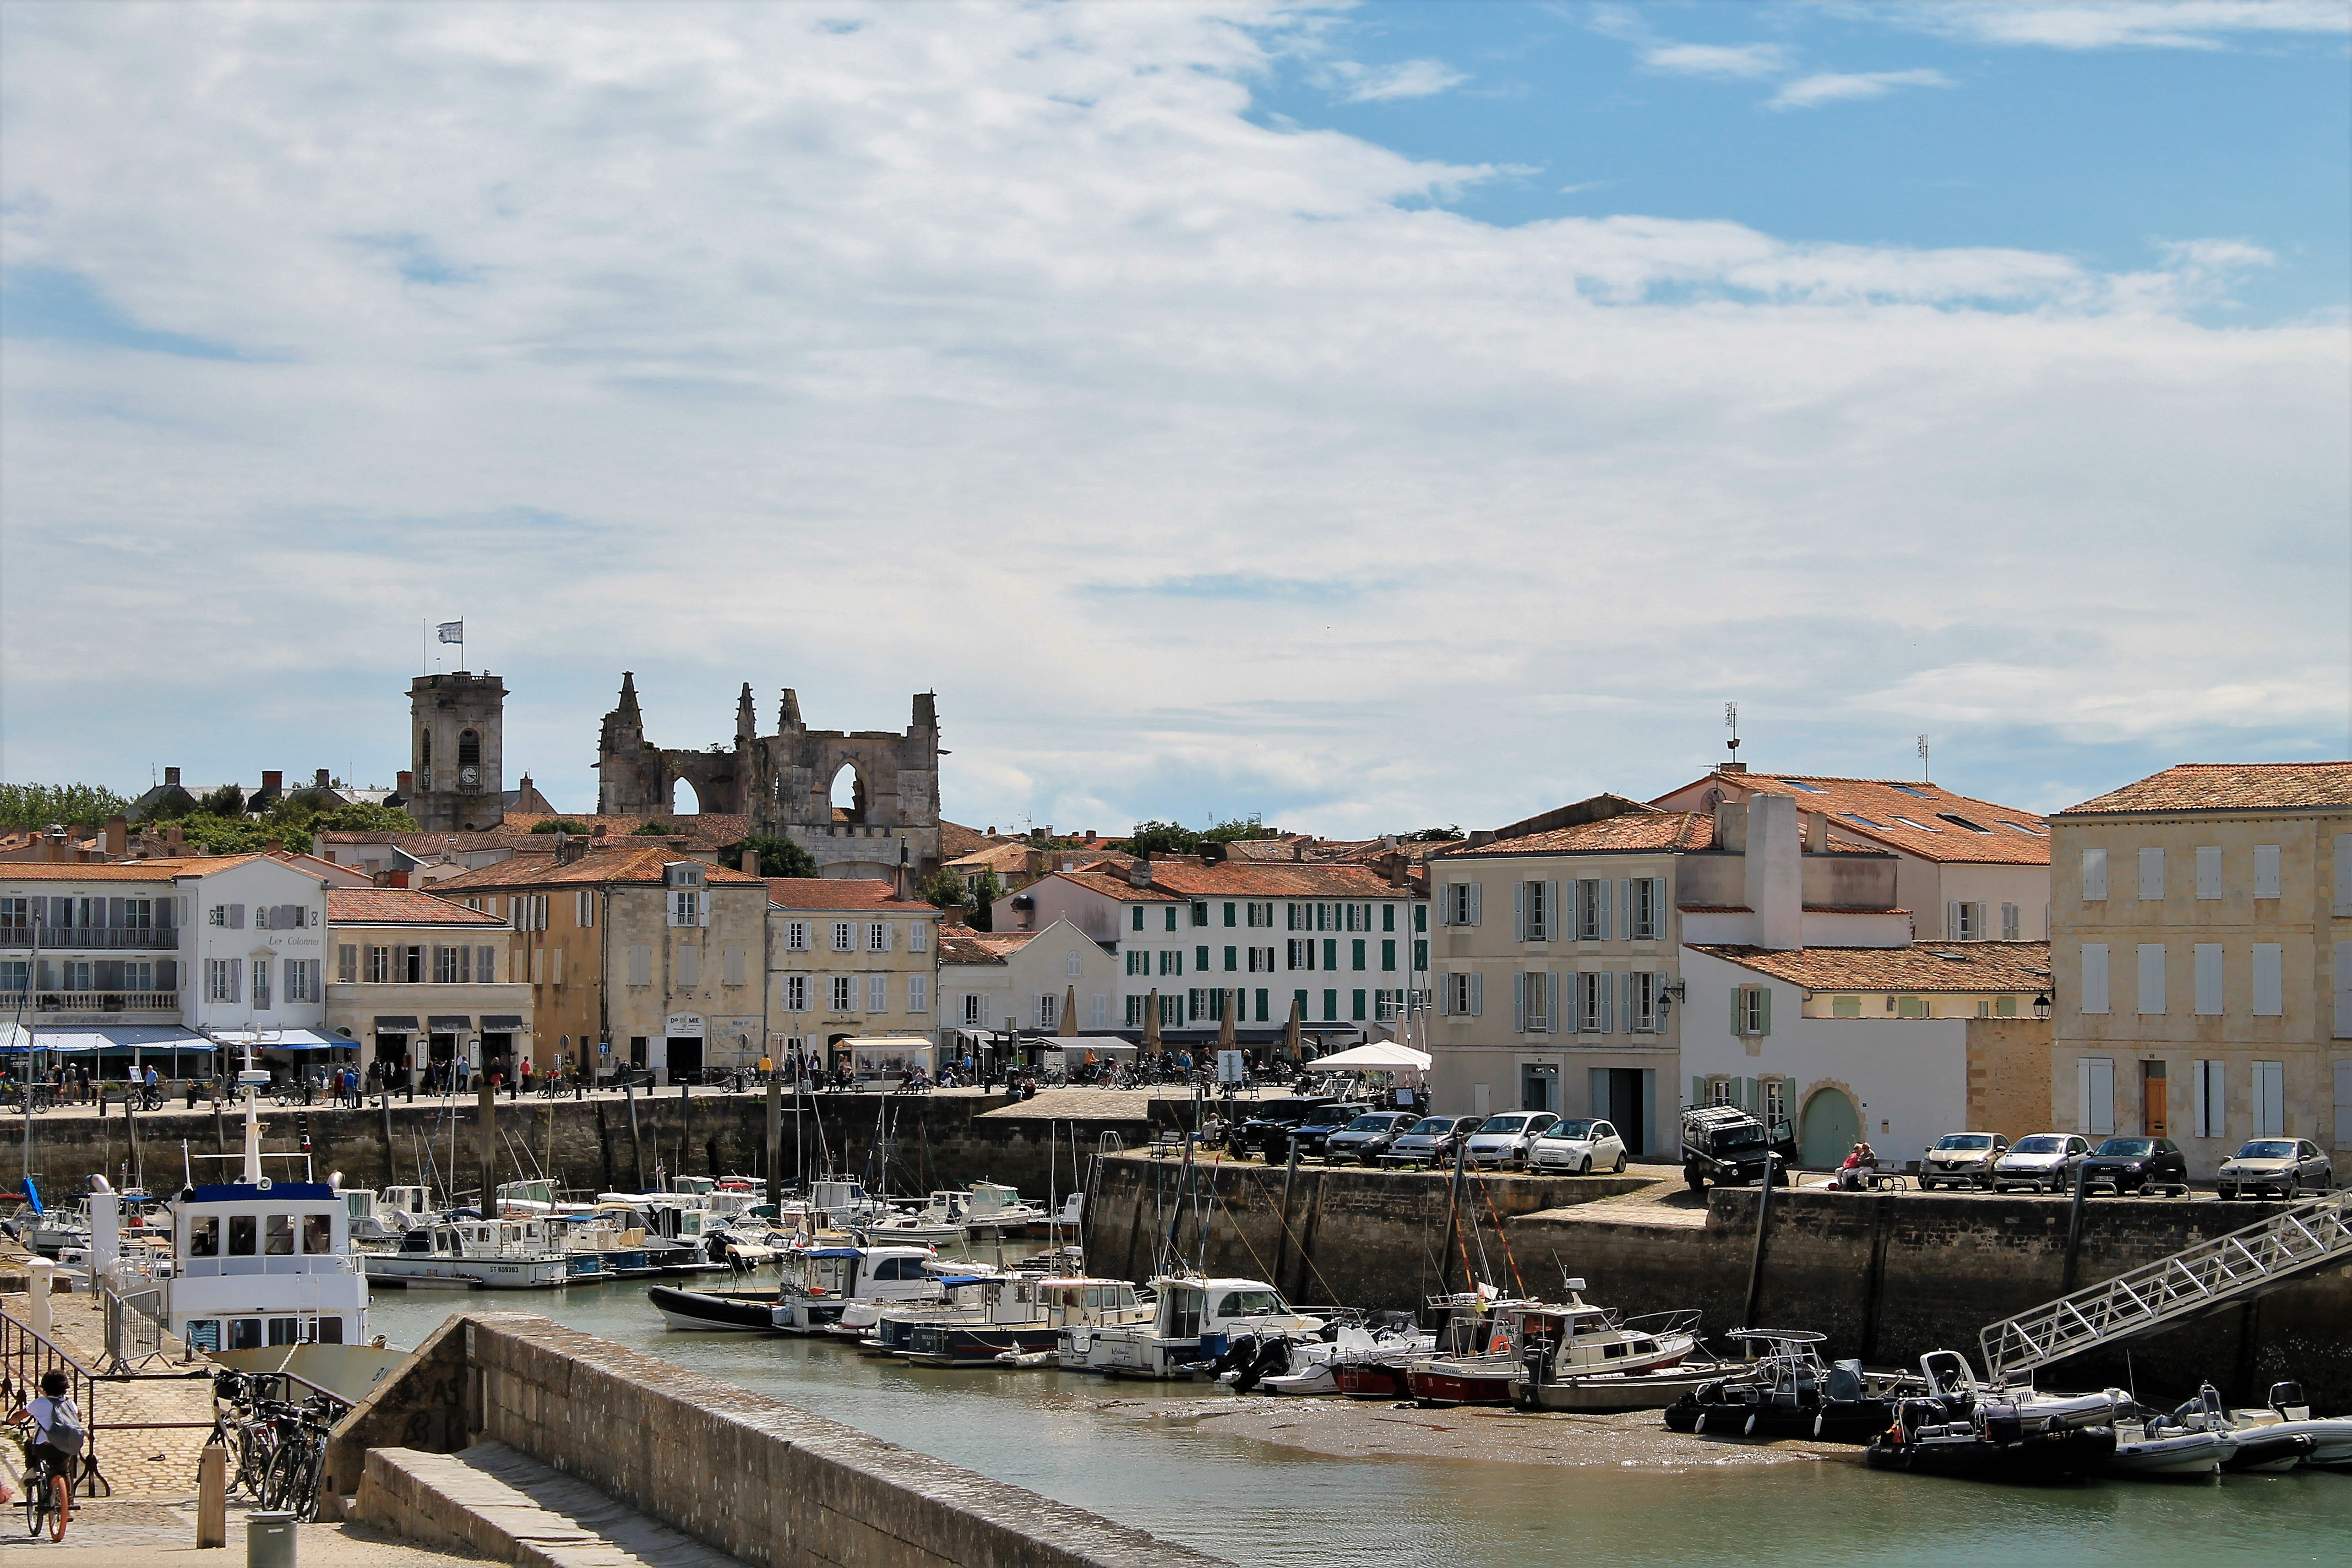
[435,839,767,1084]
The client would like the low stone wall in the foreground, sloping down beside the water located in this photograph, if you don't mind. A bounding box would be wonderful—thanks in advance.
[343,1312,1230,1568]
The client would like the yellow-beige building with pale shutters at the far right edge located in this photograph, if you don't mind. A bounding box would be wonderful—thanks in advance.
[2049,761,2352,1175]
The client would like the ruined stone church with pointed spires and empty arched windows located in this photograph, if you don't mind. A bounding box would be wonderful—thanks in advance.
[597,670,941,881]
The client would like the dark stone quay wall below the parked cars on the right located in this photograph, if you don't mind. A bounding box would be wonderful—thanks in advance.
[1087,1155,2352,1411]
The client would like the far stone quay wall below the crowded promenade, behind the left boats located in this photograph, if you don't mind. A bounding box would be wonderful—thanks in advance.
[18,1088,1157,1201]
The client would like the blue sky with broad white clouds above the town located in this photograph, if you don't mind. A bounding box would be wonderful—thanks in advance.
[0,0,2352,835]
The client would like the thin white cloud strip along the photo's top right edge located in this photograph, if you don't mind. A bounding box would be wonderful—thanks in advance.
[1909,0,2352,50]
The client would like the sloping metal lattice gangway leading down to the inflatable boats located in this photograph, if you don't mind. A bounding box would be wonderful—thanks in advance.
[1975,1192,2352,1382]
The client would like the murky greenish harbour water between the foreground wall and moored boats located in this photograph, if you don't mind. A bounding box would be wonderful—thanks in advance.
[369,1283,2352,1568]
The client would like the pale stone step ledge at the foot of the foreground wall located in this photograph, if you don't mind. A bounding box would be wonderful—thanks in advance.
[351,1444,738,1568]
